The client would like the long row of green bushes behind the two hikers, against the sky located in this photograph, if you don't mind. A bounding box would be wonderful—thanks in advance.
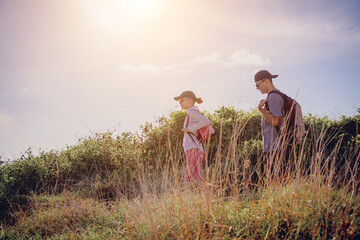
[0,107,360,222]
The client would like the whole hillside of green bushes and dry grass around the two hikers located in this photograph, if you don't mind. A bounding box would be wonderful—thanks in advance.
[0,107,360,239]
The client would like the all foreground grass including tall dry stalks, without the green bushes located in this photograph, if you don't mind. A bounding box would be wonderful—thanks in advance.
[0,115,360,239]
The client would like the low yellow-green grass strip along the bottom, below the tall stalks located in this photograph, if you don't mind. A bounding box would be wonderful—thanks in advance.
[2,182,360,239]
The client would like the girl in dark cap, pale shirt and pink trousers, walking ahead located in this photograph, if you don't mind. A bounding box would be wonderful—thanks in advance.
[174,91,214,182]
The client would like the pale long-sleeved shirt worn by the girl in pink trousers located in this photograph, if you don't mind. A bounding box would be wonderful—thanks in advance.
[183,106,210,152]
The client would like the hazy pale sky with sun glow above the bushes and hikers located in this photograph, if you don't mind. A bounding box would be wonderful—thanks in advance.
[0,0,360,160]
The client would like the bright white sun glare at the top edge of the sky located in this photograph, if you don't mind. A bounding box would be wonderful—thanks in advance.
[83,0,162,31]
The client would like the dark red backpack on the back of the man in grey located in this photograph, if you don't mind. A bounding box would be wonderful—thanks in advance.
[266,90,305,143]
